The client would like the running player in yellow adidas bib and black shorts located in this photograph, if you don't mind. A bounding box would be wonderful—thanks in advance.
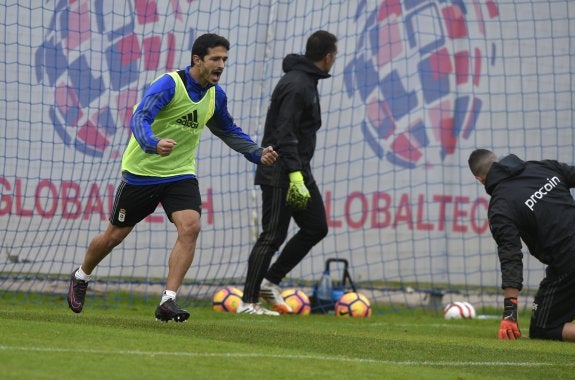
[68,34,277,322]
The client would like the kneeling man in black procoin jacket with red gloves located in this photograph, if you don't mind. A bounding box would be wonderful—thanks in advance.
[468,149,575,341]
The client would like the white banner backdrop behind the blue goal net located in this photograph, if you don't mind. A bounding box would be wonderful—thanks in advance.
[0,0,575,286]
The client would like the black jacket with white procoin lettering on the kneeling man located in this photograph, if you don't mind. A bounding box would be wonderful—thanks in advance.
[485,154,575,290]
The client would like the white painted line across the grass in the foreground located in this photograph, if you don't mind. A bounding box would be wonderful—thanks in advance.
[0,345,575,367]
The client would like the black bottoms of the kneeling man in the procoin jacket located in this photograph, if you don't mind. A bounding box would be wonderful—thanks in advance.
[529,269,575,340]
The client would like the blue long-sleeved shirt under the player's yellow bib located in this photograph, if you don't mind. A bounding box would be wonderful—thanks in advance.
[124,66,262,184]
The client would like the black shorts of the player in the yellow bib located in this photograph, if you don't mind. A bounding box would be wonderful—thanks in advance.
[110,178,202,227]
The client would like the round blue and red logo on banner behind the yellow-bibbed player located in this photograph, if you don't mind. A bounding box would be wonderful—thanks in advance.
[35,0,187,157]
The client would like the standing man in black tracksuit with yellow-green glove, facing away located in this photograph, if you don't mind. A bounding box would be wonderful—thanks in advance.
[237,31,337,315]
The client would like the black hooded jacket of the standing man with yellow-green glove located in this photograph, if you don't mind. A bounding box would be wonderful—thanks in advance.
[255,54,330,188]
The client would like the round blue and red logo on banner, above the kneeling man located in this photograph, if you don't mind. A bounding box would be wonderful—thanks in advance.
[344,0,499,168]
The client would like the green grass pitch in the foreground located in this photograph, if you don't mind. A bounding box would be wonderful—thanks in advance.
[0,294,575,380]
